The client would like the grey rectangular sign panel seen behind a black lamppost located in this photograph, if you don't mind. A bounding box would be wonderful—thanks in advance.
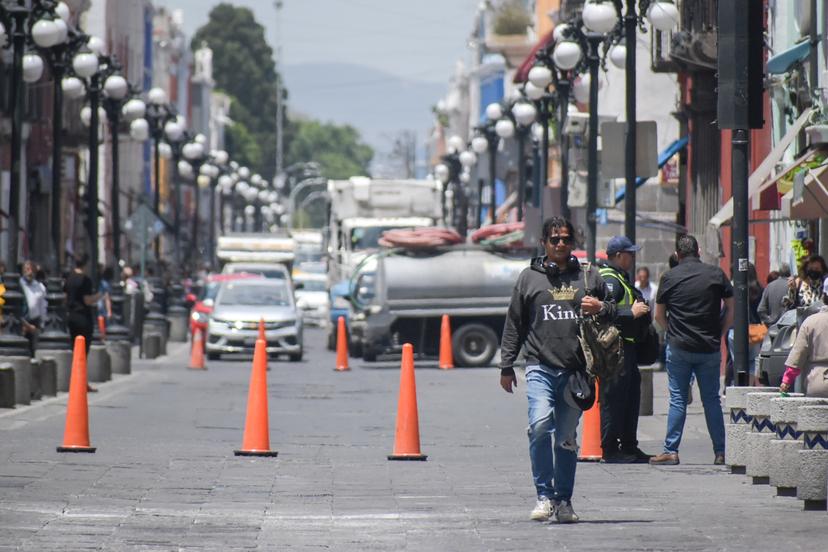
[601,121,658,178]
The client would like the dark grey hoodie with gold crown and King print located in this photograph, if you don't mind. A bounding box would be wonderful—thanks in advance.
[500,257,615,375]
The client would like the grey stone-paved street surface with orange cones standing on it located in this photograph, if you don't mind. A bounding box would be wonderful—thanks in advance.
[0,332,828,552]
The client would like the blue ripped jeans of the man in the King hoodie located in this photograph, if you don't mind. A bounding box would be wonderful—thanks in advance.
[526,366,581,500]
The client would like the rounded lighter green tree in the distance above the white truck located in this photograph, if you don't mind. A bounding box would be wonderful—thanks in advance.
[286,120,374,179]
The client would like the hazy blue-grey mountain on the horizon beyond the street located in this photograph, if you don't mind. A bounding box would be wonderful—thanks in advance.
[282,63,447,166]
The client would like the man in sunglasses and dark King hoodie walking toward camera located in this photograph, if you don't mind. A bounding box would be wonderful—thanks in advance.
[500,217,615,523]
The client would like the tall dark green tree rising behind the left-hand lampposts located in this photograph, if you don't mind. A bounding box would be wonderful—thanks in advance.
[191,3,279,178]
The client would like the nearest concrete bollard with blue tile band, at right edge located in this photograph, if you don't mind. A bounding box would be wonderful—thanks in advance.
[796,405,828,510]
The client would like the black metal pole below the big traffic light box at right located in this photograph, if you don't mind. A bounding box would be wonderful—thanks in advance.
[731,129,749,385]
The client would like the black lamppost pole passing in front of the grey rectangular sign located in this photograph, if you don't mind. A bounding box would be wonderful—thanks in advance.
[624,0,638,254]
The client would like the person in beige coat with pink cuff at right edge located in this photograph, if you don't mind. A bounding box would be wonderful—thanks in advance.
[779,280,828,397]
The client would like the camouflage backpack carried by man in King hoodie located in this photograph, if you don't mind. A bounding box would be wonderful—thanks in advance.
[578,263,624,381]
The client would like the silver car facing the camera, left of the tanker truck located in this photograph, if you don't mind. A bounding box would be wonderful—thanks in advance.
[205,278,303,361]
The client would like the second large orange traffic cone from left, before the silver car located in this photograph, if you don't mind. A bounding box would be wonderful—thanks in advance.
[235,339,279,456]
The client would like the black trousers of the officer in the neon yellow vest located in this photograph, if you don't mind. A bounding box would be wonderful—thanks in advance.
[599,342,641,454]
